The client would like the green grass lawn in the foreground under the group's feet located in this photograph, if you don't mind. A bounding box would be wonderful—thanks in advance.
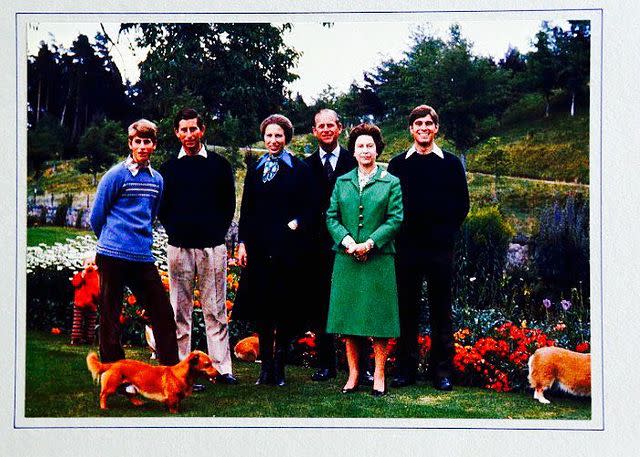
[25,331,591,420]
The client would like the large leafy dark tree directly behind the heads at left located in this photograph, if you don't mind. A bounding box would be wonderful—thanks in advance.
[121,23,299,141]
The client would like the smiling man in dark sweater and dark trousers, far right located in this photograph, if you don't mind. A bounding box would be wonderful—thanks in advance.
[388,105,469,391]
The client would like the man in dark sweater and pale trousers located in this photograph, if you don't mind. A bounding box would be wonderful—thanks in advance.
[158,108,237,384]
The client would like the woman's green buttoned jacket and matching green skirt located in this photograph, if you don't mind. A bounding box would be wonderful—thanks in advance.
[327,168,402,338]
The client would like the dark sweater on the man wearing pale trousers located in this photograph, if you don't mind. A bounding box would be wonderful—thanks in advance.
[158,151,236,248]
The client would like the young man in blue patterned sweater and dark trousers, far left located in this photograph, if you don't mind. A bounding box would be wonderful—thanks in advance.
[91,119,178,365]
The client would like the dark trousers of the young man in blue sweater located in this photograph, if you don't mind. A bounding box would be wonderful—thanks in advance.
[96,254,179,365]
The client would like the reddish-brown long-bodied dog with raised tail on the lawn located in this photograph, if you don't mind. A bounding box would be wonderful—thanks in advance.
[87,351,219,413]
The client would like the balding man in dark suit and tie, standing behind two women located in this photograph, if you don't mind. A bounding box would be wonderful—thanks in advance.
[305,109,372,384]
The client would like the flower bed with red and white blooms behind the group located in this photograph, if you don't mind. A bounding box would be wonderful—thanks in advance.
[27,222,590,391]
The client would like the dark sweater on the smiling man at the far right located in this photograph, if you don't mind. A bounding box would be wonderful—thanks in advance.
[388,151,469,255]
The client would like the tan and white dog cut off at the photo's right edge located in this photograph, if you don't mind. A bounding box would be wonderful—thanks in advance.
[529,346,591,403]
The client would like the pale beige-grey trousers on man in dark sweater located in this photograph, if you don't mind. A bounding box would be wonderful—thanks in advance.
[167,244,231,374]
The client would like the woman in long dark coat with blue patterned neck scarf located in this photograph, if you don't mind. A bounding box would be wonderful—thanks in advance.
[233,114,312,386]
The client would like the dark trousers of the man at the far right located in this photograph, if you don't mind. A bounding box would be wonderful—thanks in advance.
[396,250,454,379]
